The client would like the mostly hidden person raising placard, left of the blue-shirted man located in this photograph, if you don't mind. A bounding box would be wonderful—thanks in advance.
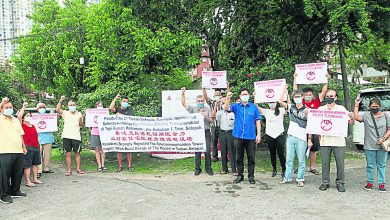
[202,88,223,162]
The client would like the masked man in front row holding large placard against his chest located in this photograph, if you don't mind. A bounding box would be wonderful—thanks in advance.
[318,90,354,192]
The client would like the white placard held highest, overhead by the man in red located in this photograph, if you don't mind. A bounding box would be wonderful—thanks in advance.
[295,62,328,84]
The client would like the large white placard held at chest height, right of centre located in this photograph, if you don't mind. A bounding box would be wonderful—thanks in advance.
[306,109,349,137]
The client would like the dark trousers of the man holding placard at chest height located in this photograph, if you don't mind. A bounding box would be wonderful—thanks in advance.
[321,146,345,184]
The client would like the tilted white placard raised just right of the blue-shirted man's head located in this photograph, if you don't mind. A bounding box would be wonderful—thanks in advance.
[254,79,286,103]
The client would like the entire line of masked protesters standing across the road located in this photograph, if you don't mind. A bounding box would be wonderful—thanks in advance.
[0,71,390,203]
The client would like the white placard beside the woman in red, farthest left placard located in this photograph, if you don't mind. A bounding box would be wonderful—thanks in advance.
[31,113,58,133]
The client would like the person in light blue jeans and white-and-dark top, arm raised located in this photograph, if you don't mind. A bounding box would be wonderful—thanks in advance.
[279,85,313,187]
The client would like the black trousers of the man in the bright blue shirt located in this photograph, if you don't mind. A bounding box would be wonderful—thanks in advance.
[234,138,256,178]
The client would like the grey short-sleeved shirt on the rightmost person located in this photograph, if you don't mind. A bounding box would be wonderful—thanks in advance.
[362,112,390,150]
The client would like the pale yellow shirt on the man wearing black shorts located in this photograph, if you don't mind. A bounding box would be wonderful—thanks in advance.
[61,111,82,141]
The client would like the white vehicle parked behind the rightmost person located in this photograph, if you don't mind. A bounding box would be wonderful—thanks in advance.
[352,86,390,150]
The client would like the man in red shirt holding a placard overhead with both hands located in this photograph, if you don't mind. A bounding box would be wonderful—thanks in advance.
[293,73,329,175]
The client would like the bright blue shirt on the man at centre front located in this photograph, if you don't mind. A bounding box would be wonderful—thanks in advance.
[230,102,261,140]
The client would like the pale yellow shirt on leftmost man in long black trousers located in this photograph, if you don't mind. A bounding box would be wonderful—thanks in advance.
[0,115,24,154]
